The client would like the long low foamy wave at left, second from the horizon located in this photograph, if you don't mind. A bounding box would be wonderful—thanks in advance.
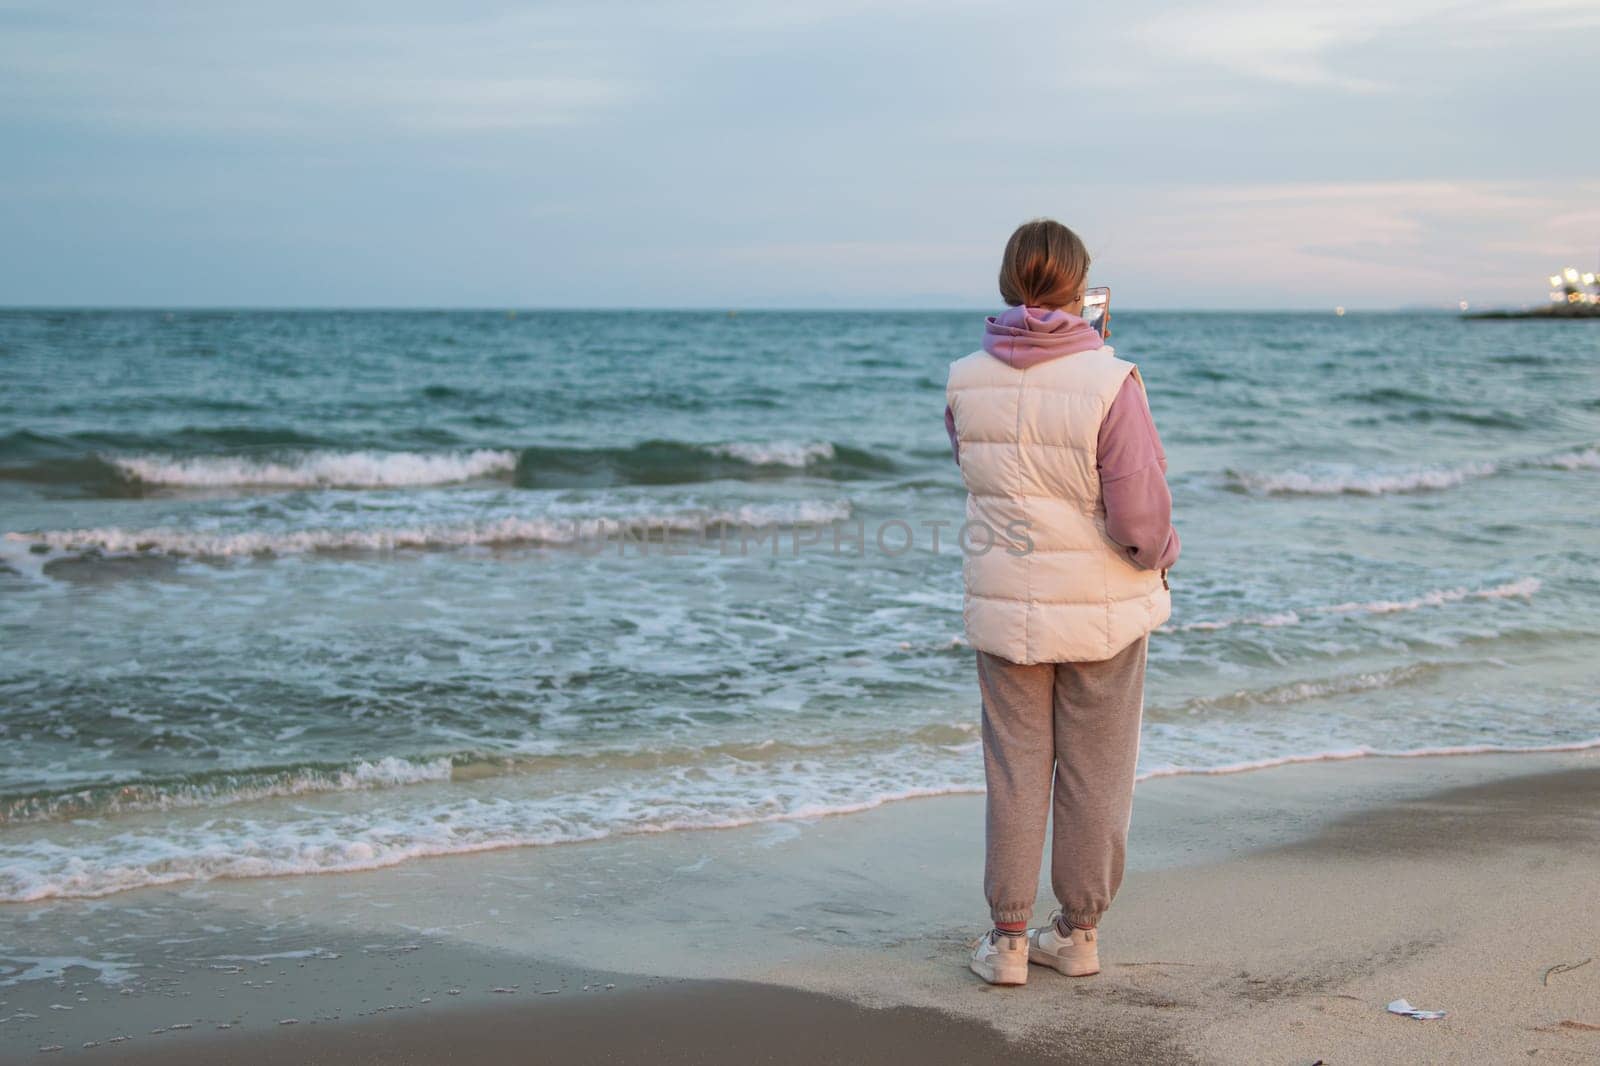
[5,501,851,559]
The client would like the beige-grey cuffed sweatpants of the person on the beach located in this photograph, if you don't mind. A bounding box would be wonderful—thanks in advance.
[978,637,1149,927]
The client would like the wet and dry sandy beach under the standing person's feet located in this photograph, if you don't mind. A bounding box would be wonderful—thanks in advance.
[0,752,1600,1063]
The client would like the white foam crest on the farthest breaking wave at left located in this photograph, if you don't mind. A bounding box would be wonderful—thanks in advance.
[106,448,517,488]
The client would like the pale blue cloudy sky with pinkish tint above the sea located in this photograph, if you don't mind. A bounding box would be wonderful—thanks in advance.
[0,0,1600,309]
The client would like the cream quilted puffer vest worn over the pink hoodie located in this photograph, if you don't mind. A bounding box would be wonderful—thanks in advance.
[946,346,1173,663]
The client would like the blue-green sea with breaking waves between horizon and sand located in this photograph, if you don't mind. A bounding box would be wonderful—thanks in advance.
[0,311,1600,901]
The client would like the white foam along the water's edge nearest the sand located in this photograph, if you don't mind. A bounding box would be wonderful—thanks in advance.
[0,738,1600,902]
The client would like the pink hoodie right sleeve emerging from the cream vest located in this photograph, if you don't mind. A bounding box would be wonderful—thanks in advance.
[1098,375,1181,570]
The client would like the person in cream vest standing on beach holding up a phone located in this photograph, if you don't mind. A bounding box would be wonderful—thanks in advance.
[944,219,1179,984]
